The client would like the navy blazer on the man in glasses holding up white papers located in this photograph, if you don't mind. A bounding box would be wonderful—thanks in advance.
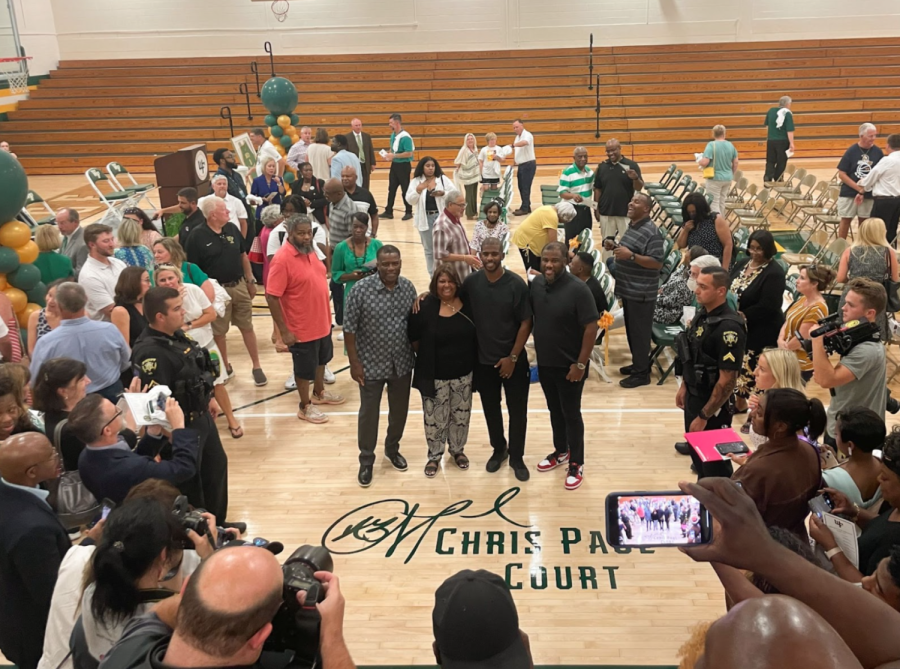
[78,429,200,504]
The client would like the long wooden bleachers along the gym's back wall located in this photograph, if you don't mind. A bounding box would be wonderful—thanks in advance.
[0,38,900,174]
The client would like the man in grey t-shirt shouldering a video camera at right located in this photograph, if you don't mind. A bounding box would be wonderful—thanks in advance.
[810,278,887,447]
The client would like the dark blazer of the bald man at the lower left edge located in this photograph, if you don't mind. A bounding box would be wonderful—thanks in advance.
[0,481,72,669]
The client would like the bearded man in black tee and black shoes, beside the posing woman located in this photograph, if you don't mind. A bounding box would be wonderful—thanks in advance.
[460,237,531,481]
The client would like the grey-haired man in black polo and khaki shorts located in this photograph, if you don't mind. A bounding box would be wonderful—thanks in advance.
[184,197,269,386]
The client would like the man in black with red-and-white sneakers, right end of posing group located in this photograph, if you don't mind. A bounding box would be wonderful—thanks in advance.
[531,242,600,490]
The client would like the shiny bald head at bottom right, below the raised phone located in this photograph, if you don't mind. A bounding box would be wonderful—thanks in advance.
[694,595,862,669]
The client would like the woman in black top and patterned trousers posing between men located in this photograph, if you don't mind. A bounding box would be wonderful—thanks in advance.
[408,263,476,478]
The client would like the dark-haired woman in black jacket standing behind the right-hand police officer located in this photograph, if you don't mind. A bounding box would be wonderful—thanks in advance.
[731,230,784,413]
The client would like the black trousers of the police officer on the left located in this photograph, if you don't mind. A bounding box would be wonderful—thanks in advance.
[181,411,228,525]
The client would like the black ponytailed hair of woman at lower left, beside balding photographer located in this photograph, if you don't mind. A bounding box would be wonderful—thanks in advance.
[85,498,185,624]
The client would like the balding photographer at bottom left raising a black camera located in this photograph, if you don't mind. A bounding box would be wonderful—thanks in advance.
[101,547,355,669]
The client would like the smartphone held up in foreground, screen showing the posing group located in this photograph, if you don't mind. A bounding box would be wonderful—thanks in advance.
[606,491,712,547]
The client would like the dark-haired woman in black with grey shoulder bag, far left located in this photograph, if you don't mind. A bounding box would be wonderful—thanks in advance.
[32,358,91,471]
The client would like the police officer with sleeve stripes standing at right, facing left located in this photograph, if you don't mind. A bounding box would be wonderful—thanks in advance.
[675,267,747,478]
